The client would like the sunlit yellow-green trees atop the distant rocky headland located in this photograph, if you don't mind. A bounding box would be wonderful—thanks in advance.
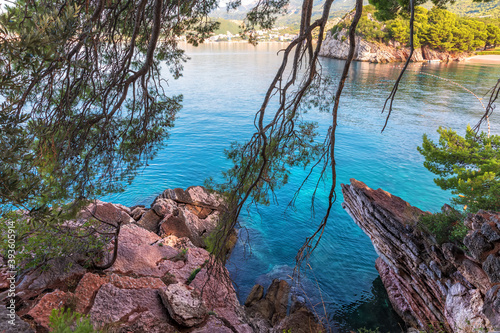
[332,6,500,52]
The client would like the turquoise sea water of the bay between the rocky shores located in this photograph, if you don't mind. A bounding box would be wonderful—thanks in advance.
[103,43,500,332]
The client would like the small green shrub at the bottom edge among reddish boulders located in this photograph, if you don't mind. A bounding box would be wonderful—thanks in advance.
[49,309,98,333]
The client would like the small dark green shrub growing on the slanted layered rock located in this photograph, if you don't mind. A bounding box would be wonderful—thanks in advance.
[418,211,468,245]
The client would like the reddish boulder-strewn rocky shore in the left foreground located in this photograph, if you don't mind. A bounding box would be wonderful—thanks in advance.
[0,186,319,333]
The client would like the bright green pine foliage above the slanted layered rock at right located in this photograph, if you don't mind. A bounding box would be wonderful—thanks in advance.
[418,126,500,213]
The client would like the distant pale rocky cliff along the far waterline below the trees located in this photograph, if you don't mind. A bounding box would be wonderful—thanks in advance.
[320,29,467,63]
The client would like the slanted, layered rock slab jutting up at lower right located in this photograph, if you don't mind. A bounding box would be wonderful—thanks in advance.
[342,179,500,332]
